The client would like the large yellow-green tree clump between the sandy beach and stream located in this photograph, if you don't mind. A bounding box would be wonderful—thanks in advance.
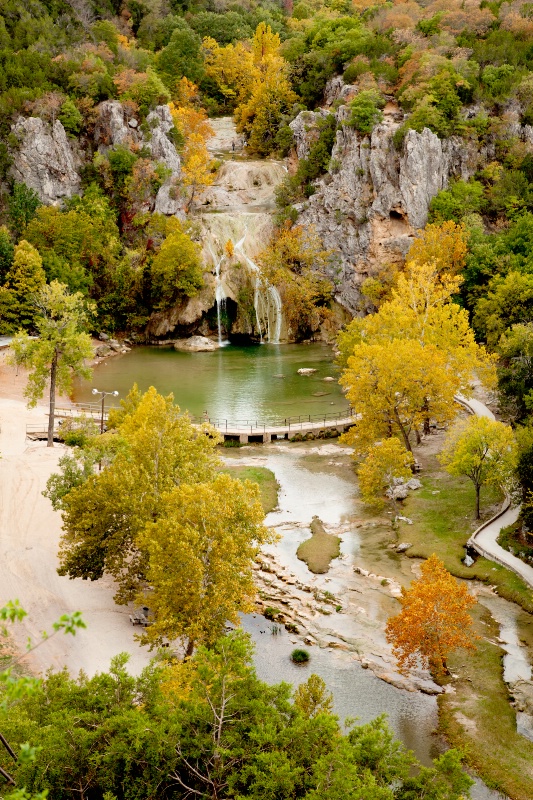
[52,387,270,654]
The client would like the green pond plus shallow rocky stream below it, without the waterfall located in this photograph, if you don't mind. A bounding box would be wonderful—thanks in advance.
[75,344,511,800]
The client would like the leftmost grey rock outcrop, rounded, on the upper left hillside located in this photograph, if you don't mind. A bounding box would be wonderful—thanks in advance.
[11,117,80,205]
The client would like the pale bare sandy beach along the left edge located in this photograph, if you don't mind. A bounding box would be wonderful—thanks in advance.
[0,350,150,675]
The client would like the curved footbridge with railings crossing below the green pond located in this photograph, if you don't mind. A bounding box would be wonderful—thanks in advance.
[26,403,356,444]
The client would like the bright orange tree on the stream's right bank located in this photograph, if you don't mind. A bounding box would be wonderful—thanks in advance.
[386,554,476,674]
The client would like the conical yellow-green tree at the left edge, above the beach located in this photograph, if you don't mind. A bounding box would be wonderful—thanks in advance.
[0,239,46,333]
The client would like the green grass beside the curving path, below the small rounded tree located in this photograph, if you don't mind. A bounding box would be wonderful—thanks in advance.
[398,457,533,612]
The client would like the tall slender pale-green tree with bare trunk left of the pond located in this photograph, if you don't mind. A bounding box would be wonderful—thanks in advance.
[11,281,94,447]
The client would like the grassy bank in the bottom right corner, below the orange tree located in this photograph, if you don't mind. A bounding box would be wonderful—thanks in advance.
[439,605,533,800]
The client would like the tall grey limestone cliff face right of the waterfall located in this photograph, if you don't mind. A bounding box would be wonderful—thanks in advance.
[291,100,478,314]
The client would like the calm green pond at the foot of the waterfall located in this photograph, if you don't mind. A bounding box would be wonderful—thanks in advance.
[74,344,348,423]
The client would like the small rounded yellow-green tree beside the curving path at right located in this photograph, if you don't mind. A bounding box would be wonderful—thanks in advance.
[439,416,517,519]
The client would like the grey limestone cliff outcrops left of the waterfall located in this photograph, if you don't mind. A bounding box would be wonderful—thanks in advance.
[11,100,183,216]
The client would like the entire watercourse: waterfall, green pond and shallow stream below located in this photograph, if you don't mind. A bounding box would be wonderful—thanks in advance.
[74,119,512,800]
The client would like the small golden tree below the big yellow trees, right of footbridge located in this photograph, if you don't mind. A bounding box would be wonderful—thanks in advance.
[357,436,414,511]
